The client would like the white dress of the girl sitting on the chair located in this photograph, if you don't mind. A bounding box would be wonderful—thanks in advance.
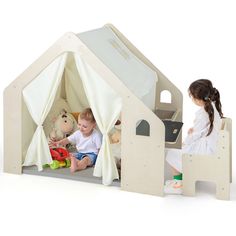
[166,103,221,172]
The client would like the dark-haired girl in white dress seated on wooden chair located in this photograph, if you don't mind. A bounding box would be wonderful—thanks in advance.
[164,79,223,194]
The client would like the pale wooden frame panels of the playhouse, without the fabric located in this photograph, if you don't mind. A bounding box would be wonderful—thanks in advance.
[4,24,231,196]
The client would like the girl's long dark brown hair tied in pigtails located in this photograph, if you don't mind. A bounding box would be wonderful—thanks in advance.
[188,79,223,136]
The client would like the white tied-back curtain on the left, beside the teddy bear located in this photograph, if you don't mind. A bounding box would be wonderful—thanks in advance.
[23,53,67,171]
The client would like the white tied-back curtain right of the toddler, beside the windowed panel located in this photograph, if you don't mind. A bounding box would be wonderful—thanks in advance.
[74,54,122,185]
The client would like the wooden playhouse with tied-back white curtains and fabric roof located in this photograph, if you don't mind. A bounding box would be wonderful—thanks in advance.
[4,25,182,196]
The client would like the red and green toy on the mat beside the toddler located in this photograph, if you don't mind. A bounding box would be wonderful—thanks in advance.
[44,148,70,170]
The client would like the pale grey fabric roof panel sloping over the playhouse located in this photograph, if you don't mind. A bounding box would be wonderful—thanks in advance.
[77,26,158,109]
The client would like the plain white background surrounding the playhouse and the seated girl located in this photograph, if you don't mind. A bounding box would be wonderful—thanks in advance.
[0,0,236,236]
